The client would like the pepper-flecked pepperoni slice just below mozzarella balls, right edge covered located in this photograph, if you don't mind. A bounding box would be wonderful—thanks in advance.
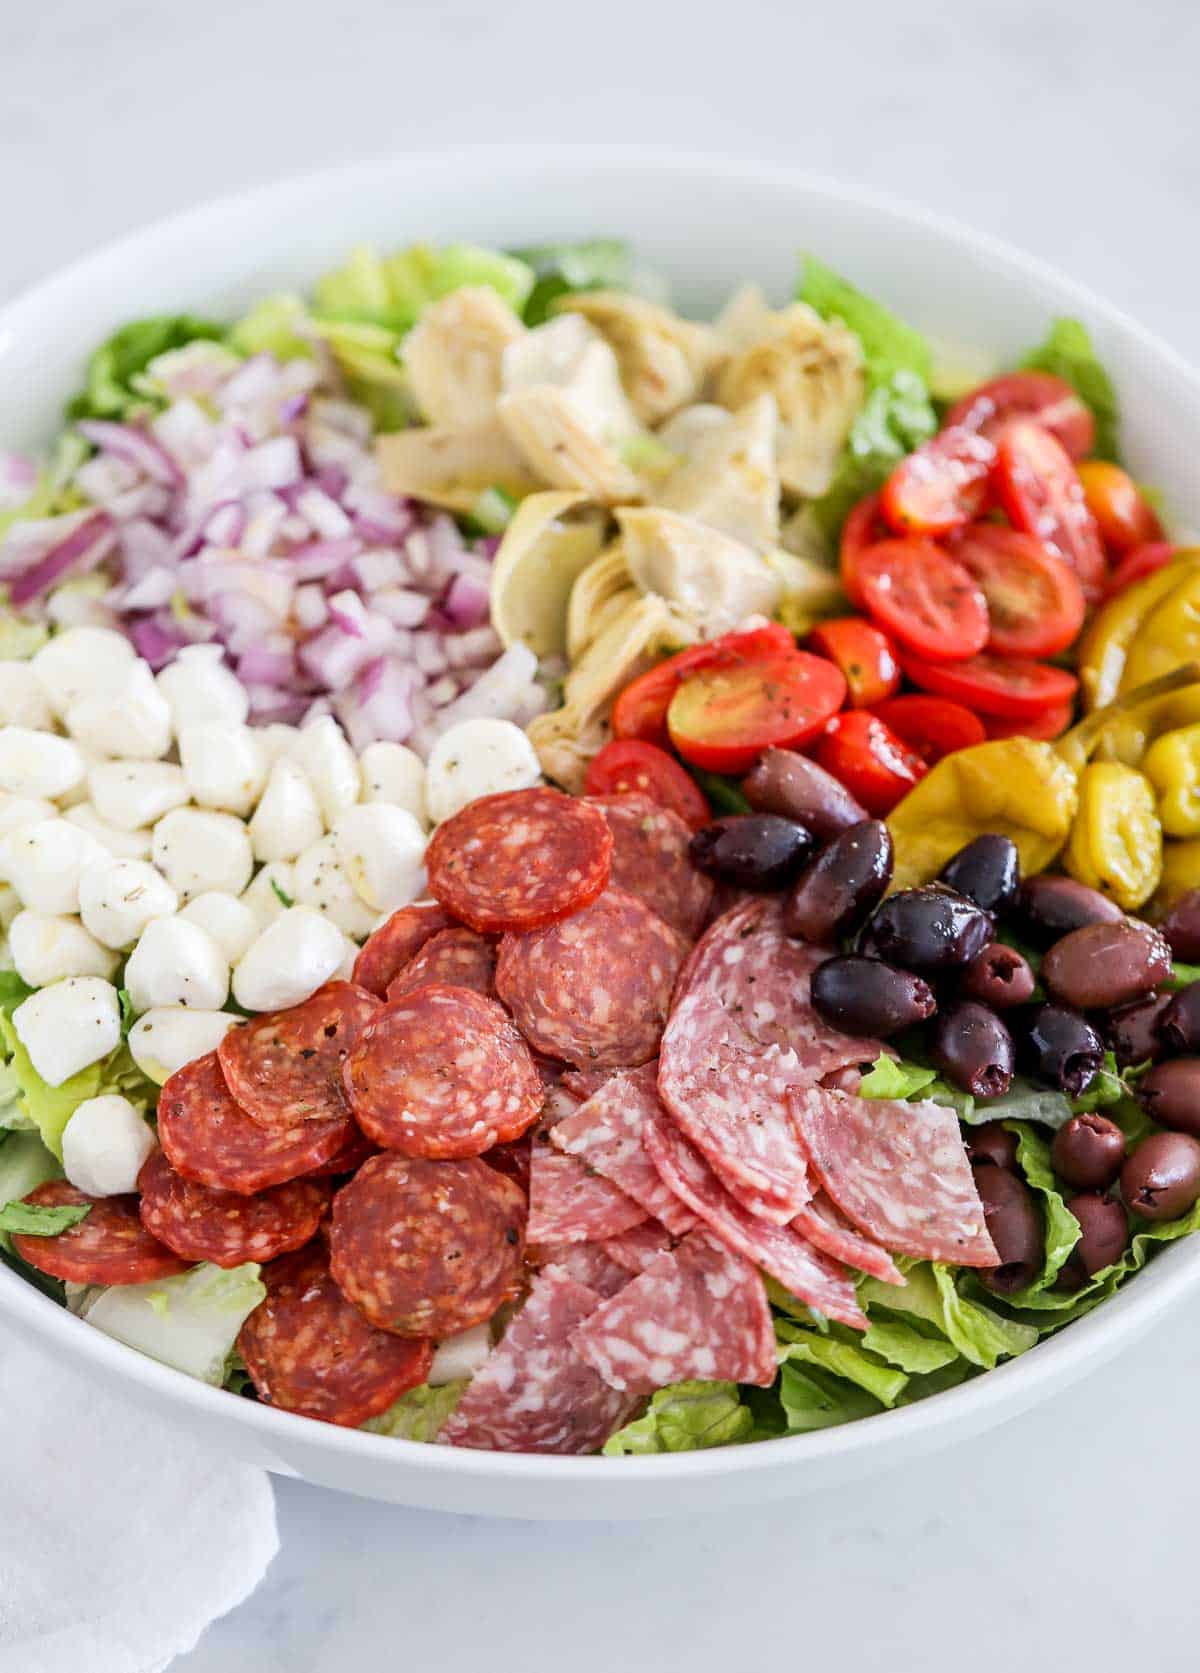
[216,982,380,1131]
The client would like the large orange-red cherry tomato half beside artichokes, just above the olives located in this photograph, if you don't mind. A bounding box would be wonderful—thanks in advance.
[666,651,845,773]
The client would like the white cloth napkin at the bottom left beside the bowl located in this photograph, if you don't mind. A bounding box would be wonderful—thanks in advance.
[0,1330,279,1673]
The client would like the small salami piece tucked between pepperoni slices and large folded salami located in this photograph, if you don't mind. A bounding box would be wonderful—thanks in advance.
[551,1062,696,1236]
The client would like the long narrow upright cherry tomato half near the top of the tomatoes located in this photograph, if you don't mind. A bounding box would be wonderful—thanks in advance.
[992,418,1108,599]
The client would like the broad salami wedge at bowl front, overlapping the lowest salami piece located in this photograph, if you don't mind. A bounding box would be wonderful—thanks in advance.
[571,1231,775,1394]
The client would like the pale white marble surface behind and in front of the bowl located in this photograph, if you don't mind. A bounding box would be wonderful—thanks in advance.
[0,0,1200,1673]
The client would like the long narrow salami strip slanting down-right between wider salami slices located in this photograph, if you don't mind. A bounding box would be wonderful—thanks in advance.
[646,1106,867,1330]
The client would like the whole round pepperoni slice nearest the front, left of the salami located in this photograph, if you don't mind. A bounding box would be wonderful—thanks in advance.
[330,1156,526,1340]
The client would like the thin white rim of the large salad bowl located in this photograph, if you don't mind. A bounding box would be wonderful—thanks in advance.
[0,142,1200,1484]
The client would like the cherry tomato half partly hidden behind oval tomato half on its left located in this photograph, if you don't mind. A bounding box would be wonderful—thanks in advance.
[951,524,1088,656]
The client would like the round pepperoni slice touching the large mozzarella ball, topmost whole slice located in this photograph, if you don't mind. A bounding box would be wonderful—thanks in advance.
[425,788,613,932]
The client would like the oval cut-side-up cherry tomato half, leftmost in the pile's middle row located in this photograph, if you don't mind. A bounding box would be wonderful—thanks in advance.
[857,540,987,663]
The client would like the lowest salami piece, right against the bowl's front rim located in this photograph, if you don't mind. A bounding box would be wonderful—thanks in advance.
[437,1268,638,1454]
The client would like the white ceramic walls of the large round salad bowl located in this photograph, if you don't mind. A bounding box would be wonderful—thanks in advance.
[0,147,1200,1517]
